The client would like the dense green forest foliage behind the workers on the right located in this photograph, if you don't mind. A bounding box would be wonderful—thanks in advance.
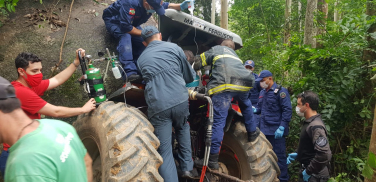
[229,0,376,182]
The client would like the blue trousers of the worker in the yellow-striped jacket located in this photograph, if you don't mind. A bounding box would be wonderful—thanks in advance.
[210,92,256,154]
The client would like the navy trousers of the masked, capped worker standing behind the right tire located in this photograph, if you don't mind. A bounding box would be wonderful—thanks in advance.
[265,135,289,182]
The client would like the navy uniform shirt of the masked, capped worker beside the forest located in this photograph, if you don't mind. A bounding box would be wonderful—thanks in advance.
[256,83,292,136]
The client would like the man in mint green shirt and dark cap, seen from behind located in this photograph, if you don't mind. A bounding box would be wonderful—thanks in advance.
[0,77,92,182]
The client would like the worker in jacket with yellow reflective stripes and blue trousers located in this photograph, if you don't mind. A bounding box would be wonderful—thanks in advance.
[194,39,260,170]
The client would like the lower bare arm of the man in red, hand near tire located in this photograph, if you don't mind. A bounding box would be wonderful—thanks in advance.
[38,98,96,118]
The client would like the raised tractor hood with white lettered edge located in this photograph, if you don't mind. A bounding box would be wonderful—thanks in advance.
[158,9,243,54]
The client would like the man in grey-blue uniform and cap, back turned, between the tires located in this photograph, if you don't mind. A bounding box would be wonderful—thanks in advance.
[137,26,198,182]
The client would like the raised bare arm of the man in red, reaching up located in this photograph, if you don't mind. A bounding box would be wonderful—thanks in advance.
[47,48,85,90]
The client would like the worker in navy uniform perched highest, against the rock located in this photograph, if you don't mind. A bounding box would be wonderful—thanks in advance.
[102,0,189,79]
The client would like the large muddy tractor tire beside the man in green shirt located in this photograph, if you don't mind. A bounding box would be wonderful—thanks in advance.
[73,101,163,182]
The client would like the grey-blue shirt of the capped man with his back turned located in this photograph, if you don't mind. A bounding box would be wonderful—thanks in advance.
[137,40,196,118]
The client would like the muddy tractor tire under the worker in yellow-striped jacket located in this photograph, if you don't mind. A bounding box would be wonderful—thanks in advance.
[219,122,280,182]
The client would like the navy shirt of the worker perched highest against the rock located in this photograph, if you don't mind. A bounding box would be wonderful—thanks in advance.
[102,0,170,33]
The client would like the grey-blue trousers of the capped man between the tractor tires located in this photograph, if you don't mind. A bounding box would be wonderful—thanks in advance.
[150,101,193,182]
